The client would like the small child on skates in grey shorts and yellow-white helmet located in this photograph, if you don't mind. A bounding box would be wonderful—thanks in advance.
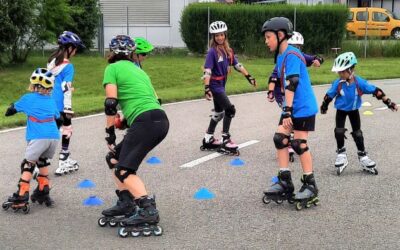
[3,68,60,213]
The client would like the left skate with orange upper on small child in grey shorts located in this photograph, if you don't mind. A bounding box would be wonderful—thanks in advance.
[2,179,30,214]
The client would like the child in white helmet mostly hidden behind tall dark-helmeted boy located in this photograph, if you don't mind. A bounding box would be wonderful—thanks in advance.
[267,31,324,162]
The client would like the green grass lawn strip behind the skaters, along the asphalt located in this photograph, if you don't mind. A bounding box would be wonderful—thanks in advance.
[0,51,400,128]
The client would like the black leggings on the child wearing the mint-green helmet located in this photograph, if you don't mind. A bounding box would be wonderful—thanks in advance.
[335,109,365,151]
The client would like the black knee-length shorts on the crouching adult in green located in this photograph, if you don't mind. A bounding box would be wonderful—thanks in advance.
[117,109,169,172]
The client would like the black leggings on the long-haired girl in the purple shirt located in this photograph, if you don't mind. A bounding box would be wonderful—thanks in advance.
[207,92,233,134]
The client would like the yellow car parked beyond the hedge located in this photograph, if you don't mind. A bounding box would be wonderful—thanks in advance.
[346,8,400,39]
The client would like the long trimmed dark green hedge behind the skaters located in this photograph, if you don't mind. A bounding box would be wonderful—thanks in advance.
[181,3,348,56]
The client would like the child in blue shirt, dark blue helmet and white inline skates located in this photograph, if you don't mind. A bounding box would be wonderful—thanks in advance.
[47,31,85,176]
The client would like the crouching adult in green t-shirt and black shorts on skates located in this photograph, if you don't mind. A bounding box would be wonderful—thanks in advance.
[99,35,169,237]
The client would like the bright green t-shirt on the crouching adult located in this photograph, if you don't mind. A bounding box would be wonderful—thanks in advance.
[103,60,161,125]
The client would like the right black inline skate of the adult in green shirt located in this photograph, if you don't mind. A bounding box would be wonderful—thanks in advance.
[118,197,163,238]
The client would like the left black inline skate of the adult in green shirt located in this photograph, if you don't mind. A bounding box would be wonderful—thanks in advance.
[97,190,136,227]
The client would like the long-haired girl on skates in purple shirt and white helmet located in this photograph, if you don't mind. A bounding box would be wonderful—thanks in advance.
[200,21,257,155]
